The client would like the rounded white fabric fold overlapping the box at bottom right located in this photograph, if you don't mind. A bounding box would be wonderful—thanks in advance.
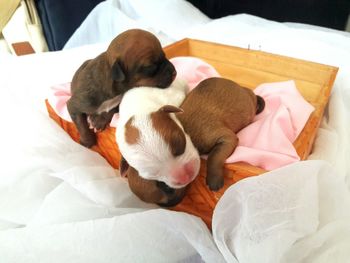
[213,161,350,263]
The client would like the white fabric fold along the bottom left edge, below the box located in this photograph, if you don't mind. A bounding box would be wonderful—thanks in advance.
[0,209,224,263]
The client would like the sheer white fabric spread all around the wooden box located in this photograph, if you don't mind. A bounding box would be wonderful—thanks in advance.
[0,0,350,263]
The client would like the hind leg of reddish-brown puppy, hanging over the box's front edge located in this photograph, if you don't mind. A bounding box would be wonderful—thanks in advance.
[206,129,238,191]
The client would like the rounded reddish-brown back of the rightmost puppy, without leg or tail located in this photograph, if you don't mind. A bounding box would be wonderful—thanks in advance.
[177,78,257,152]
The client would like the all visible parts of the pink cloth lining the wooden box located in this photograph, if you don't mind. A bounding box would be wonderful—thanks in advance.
[48,57,314,170]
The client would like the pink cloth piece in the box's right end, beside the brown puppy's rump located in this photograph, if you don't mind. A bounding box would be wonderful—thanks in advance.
[226,81,314,170]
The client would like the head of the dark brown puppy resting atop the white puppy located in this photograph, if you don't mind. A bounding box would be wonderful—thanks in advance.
[106,29,176,92]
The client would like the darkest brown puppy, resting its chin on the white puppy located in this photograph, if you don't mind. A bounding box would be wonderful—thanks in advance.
[67,29,176,147]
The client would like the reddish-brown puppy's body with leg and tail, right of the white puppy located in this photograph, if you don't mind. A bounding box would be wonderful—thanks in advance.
[177,78,265,191]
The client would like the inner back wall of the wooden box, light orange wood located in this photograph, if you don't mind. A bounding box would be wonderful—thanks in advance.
[164,39,338,104]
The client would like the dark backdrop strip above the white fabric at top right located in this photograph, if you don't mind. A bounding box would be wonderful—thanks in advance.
[187,0,350,30]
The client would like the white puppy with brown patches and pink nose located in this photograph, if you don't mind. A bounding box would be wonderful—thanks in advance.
[116,78,200,188]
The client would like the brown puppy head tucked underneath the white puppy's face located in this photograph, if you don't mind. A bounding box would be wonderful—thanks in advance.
[120,157,187,207]
